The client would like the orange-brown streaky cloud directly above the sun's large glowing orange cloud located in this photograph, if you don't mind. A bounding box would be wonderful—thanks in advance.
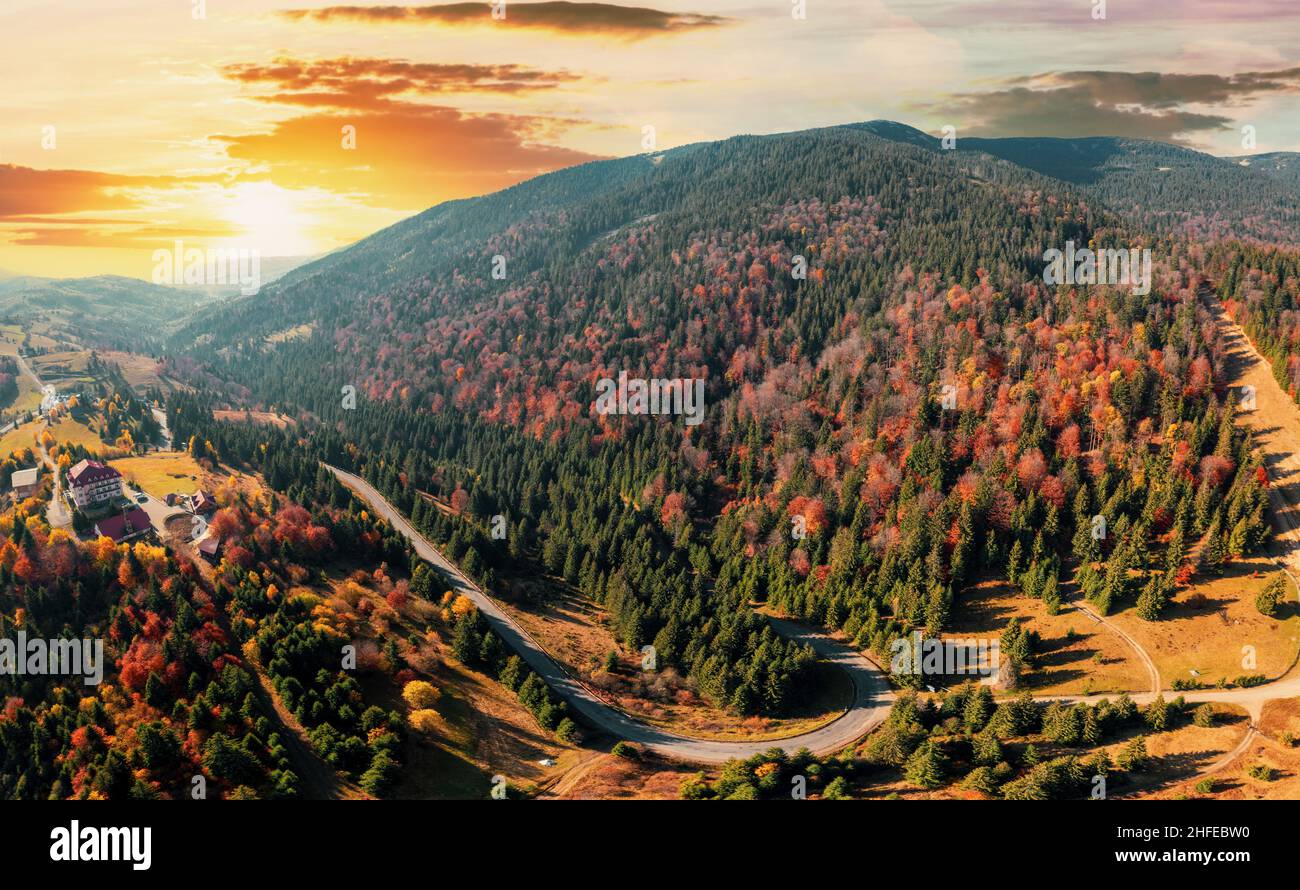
[222,58,582,110]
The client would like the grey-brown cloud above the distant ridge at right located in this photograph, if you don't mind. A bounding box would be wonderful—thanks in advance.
[924,69,1300,142]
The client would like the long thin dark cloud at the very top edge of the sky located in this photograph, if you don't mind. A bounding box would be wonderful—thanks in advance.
[280,1,735,39]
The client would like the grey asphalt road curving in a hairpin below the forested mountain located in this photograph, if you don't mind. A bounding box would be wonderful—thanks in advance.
[325,464,893,764]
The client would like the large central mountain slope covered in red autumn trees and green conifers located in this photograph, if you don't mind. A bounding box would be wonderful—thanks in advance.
[157,119,1268,712]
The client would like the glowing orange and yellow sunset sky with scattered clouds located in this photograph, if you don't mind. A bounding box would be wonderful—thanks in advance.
[0,0,1300,279]
